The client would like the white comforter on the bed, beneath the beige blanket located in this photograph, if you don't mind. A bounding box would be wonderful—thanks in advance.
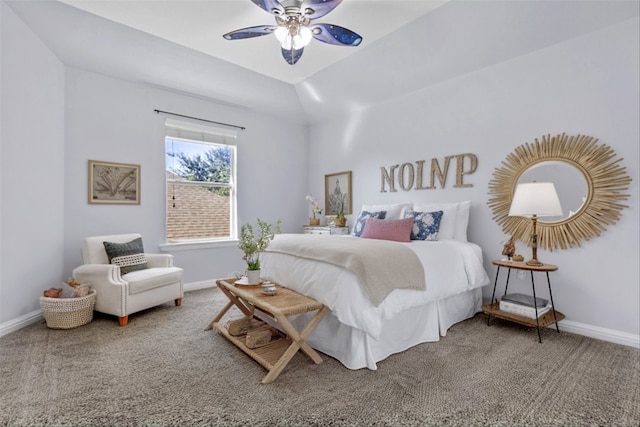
[261,236,489,339]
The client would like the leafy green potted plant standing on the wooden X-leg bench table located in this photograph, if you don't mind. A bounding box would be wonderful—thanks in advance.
[238,218,281,284]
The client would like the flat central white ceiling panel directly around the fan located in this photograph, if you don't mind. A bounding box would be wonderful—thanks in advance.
[60,0,448,83]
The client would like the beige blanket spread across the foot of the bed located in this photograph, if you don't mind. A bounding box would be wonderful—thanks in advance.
[266,234,426,307]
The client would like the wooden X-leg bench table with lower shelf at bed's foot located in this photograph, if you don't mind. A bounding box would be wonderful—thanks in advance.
[206,278,328,384]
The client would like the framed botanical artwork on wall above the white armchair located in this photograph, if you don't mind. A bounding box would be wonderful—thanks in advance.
[89,160,140,205]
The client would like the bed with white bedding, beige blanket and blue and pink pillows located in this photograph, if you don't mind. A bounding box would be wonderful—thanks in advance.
[261,202,489,370]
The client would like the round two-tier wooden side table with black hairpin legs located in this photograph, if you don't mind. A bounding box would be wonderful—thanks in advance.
[482,260,565,343]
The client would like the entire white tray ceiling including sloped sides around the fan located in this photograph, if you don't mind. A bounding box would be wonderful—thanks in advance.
[7,0,640,123]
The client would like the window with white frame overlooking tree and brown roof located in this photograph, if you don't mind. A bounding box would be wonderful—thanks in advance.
[165,119,237,243]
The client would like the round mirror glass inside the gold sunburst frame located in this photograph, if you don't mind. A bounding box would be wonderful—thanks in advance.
[518,160,589,223]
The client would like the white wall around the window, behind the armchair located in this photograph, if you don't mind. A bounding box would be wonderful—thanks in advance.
[64,68,308,283]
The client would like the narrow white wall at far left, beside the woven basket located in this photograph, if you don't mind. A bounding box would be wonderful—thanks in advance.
[0,3,65,324]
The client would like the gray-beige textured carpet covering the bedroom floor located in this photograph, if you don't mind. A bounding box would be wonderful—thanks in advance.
[0,289,640,426]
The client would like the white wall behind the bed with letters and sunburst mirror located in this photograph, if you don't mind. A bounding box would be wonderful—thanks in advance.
[309,18,640,342]
